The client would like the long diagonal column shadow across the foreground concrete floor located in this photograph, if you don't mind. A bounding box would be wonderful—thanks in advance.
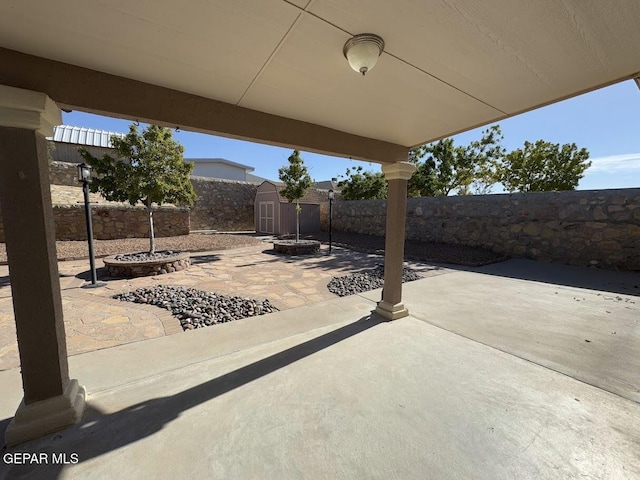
[0,312,384,480]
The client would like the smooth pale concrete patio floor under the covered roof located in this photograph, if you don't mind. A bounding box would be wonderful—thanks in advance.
[0,260,640,480]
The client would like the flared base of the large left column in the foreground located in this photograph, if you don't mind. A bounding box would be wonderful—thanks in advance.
[5,380,85,446]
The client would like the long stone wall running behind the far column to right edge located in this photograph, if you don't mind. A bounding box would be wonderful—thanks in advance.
[333,189,640,271]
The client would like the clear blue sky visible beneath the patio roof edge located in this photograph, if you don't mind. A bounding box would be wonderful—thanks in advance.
[63,81,640,192]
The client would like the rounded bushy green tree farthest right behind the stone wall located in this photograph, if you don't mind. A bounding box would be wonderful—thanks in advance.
[497,140,591,192]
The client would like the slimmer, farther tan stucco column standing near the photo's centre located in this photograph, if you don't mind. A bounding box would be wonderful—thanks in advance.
[376,162,416,320]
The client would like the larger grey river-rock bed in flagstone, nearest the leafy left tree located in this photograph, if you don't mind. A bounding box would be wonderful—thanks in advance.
[113,285,278,330]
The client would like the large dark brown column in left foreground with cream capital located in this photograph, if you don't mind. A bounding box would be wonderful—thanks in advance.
[0,85,85,445]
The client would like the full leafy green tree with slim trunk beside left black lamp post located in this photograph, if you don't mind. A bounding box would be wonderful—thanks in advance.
[79,124,196,253]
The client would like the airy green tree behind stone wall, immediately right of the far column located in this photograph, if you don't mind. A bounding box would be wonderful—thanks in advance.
[408,125,504,197]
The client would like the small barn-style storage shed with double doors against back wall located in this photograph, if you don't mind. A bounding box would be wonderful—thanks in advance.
[254,180,327,235]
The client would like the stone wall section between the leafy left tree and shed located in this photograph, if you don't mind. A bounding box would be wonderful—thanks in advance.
[191,177,258,232]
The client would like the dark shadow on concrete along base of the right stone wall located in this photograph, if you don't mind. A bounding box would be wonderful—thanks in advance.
[446,258,640,296]
